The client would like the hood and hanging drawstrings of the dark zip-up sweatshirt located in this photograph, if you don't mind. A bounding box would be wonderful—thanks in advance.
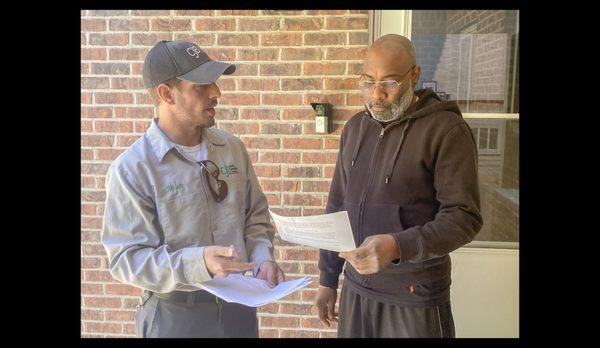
[352,88,462,184]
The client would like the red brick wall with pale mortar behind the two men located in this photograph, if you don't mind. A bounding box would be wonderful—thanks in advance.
[81,10,369,337]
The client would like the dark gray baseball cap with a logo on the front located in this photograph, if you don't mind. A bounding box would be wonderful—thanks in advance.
[143,40,235,88]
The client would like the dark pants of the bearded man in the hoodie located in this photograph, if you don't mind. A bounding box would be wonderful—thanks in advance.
[338,284,454,338]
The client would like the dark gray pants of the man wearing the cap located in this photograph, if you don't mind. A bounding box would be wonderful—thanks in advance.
[135,295,258,338]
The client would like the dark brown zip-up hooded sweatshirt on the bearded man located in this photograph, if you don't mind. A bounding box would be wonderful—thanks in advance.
[319,89,483,306]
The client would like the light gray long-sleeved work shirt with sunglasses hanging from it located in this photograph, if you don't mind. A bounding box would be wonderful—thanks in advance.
[102,119,275,293]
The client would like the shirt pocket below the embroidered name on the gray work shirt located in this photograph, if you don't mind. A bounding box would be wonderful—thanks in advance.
[157,191,210,249]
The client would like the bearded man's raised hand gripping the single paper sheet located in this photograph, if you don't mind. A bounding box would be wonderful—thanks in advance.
[339,234,400,274]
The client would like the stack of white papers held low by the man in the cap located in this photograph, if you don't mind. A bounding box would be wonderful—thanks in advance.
[200,274,311,307]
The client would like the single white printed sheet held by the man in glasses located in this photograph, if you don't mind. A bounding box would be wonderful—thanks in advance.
[269,210,356,252]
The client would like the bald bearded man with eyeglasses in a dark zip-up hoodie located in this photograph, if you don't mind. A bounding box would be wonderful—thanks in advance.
[315,34,483,338]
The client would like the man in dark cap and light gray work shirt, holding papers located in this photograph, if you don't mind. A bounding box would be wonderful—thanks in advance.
[102,41,284,337]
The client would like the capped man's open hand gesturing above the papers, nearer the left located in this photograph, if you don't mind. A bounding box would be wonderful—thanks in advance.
[204,245,254,277]
